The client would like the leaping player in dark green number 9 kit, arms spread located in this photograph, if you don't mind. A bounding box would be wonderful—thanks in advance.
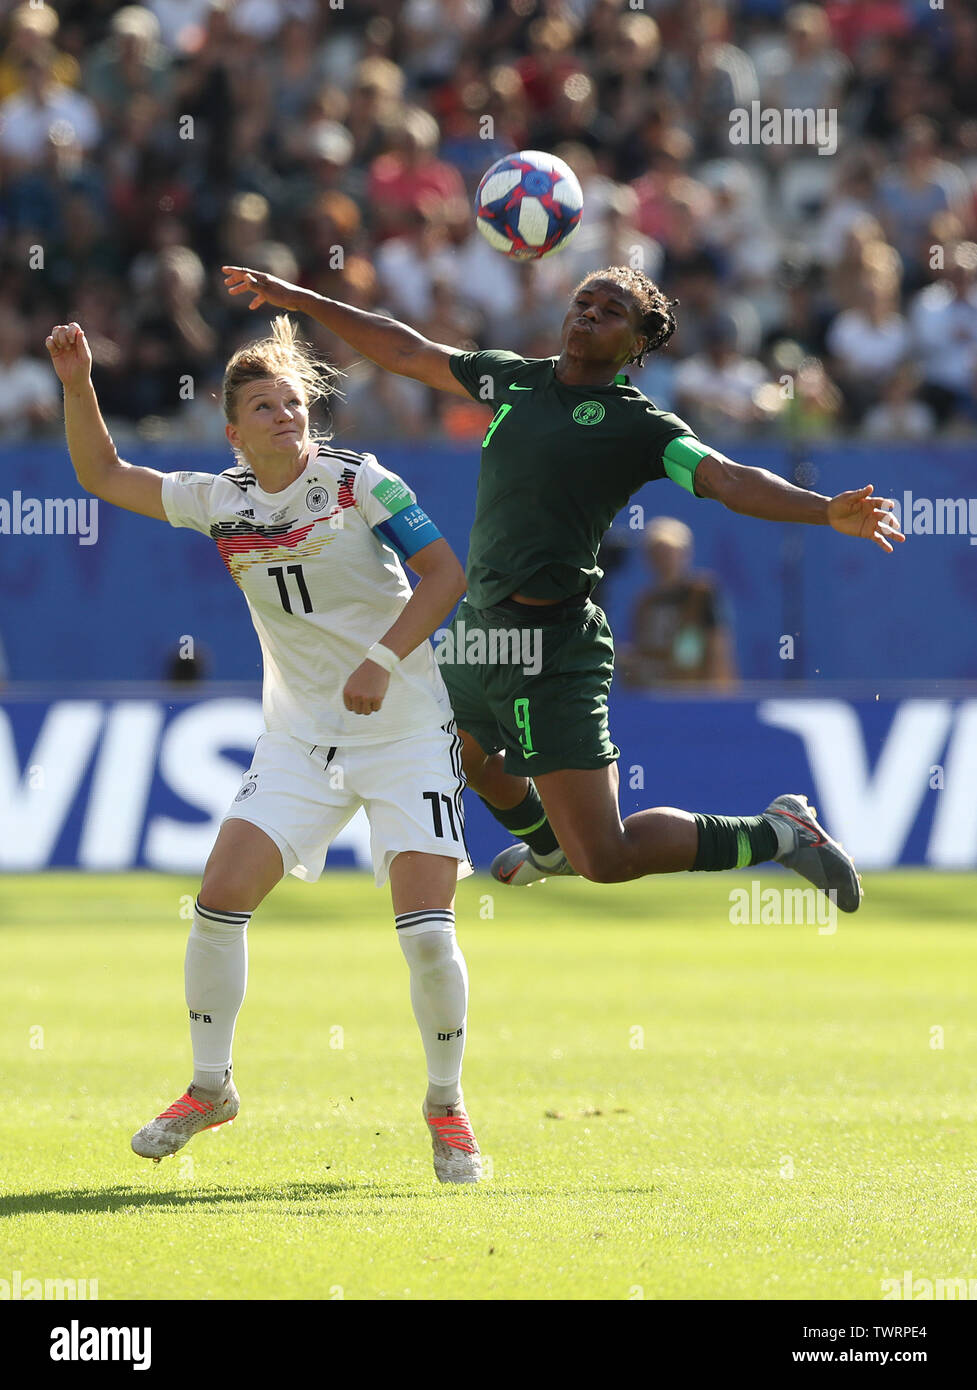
[224,265,905,912]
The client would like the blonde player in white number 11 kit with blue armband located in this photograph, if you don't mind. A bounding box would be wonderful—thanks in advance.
[47,316,481,1183]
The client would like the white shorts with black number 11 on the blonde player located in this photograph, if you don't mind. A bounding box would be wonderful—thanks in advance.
[224,716,474,888]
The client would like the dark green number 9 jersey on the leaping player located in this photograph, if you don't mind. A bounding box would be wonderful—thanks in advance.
[450,352,705,609]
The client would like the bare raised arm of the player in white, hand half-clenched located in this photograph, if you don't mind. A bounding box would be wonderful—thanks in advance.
[46,324,167,521]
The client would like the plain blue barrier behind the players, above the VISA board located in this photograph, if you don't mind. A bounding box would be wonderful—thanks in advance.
[0,439,977,684]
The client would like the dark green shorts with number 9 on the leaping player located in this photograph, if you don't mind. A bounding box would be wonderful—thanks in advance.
[435,599,620,777]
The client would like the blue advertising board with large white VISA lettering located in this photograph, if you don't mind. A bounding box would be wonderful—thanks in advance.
[0,687,977,873]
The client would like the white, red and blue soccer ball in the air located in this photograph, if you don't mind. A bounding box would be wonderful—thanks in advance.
[475,150,584,260]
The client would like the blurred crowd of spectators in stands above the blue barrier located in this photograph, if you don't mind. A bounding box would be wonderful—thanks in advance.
[0,0,977,443]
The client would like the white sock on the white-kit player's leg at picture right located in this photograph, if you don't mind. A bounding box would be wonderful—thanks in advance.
[396,908,468,1105]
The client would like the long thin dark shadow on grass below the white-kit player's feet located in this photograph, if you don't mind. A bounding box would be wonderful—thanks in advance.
[0,1182,655,1218]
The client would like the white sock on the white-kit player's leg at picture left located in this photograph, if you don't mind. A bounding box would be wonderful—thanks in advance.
[183,899,252,1091]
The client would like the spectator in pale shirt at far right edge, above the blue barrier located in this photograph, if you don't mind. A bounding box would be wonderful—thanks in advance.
[909,242,977,425]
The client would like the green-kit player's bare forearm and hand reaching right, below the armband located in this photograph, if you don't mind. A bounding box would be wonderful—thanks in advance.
[695,455,906,552]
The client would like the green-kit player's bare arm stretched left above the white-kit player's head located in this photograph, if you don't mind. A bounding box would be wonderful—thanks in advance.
[221,265,468,398]
